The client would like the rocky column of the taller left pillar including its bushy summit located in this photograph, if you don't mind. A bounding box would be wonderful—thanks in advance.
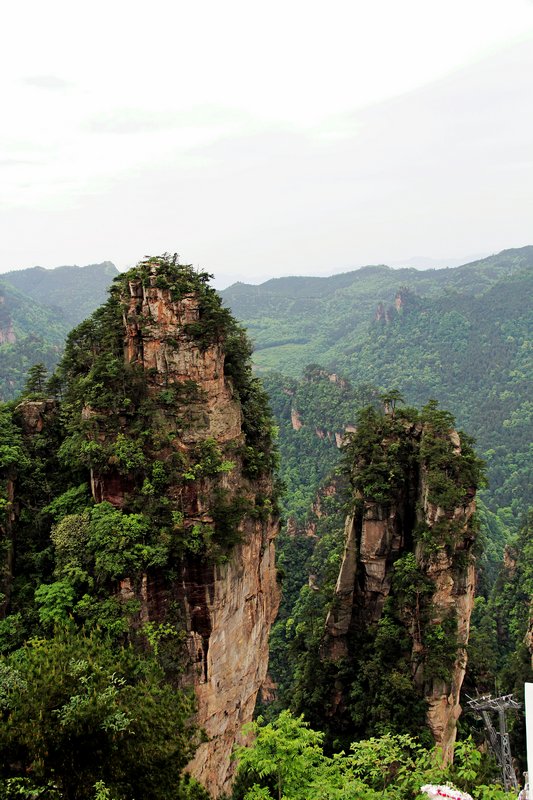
[68,259,279,797]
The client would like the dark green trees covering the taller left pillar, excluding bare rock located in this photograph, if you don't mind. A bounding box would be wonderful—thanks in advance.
[0,255,276,800]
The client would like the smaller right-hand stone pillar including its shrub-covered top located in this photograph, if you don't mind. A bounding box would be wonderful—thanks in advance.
[322,406,476,761]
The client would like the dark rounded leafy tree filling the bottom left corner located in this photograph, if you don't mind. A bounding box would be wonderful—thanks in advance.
[0,628,205,800]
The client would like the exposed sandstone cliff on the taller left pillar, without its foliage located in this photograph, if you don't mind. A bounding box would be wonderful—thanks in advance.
[82,268,279,797]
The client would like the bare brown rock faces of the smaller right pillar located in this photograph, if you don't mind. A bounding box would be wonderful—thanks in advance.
[323,416,475,761]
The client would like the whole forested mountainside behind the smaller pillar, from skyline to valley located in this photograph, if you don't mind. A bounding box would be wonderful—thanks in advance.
[228,248,533,788]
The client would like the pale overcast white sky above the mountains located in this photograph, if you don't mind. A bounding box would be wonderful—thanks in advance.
[0,0,533,288]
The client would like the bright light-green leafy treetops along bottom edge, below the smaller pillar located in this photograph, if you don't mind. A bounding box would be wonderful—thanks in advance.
[233,711,502,800]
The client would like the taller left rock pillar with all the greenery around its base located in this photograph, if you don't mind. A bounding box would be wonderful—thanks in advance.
[0,255,279,800]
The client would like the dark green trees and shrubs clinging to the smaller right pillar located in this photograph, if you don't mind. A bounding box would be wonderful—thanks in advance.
[271,400,483,747]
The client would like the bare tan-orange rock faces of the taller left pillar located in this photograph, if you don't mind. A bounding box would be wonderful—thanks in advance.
[117,272,279,797]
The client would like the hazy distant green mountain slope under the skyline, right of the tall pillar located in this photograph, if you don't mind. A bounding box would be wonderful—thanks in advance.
[222,247,533,530]
